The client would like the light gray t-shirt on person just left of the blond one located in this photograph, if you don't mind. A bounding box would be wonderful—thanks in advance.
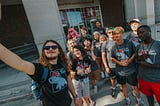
[101,40,116,68]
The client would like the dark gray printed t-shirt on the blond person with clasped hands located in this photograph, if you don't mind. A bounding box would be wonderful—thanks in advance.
[111,39,136,76]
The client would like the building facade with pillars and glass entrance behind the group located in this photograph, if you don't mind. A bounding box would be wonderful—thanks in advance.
[0,0,160,50]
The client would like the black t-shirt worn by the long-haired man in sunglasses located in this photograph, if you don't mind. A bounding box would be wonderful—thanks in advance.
[29,63,71,106]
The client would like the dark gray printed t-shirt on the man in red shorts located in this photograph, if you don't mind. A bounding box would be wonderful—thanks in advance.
[136,40,160,82]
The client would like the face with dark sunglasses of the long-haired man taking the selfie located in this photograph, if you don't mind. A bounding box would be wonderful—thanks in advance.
[43,42,59,60]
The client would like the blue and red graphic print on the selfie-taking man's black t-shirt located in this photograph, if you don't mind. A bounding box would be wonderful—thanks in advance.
[48,68,67,93]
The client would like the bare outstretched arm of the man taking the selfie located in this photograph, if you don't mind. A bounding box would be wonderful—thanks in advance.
[0,44,35,75]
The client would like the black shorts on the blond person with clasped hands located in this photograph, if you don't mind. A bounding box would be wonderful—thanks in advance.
[117,72,138,86]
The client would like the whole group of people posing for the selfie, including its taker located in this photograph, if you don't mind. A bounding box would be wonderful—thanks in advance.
[0,19,160,106]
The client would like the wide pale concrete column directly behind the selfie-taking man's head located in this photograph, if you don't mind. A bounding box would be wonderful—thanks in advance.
[22,0,66,52]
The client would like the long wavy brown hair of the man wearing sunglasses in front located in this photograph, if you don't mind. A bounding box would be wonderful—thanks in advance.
[38,40,69,70]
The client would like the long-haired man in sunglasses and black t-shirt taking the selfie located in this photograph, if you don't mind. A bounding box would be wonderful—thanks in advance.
[0,40,78,106]
